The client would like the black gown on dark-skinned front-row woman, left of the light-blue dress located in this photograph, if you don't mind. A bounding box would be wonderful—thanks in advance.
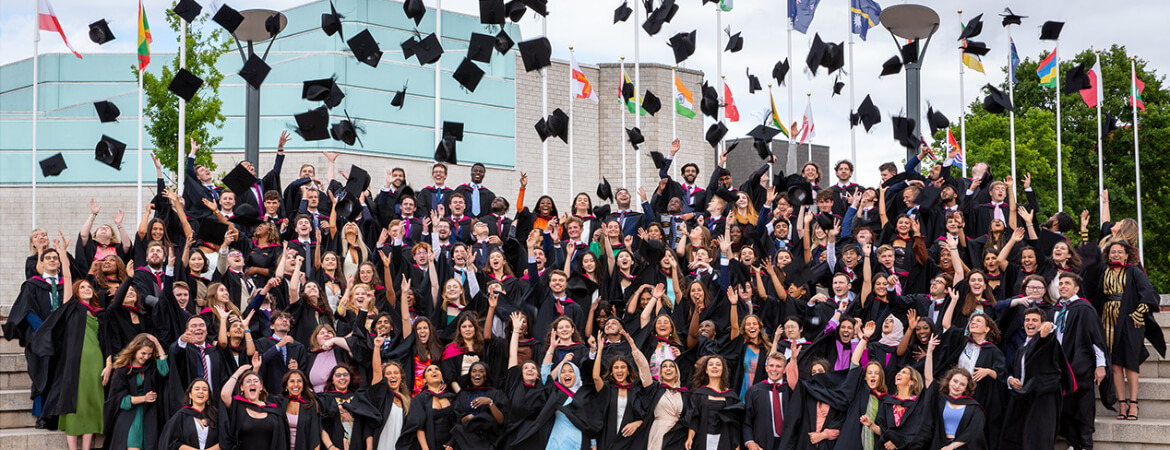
[450,387,508,450]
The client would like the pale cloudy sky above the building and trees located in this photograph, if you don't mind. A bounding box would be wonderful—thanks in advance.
[0,0,1170,185]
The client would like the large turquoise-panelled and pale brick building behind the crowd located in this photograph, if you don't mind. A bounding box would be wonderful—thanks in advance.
[0,0,714,294]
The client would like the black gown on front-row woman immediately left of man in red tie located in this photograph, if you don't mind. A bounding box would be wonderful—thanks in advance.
[682,386,744,450]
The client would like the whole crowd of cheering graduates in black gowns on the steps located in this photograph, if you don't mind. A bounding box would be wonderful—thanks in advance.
[4,134,1165,450]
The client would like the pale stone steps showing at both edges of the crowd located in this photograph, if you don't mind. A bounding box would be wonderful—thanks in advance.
[0,303,1170,450]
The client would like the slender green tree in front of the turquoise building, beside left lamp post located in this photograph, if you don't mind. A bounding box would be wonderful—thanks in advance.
[131,4,230,180]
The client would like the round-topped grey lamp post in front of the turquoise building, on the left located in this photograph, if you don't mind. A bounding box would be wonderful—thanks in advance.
[232,9,289,167]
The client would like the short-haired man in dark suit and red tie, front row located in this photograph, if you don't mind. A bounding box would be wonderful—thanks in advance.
[743,353,800,450]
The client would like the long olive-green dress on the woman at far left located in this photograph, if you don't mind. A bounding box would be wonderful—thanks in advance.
[59,314,105,436]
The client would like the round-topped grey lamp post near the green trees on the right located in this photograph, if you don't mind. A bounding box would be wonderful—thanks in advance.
[881,5,940,160]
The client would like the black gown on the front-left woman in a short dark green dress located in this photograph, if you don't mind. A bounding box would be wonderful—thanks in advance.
[102,360,166,450]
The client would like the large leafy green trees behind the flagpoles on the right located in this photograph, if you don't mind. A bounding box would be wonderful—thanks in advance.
[950,46,1170,292]
